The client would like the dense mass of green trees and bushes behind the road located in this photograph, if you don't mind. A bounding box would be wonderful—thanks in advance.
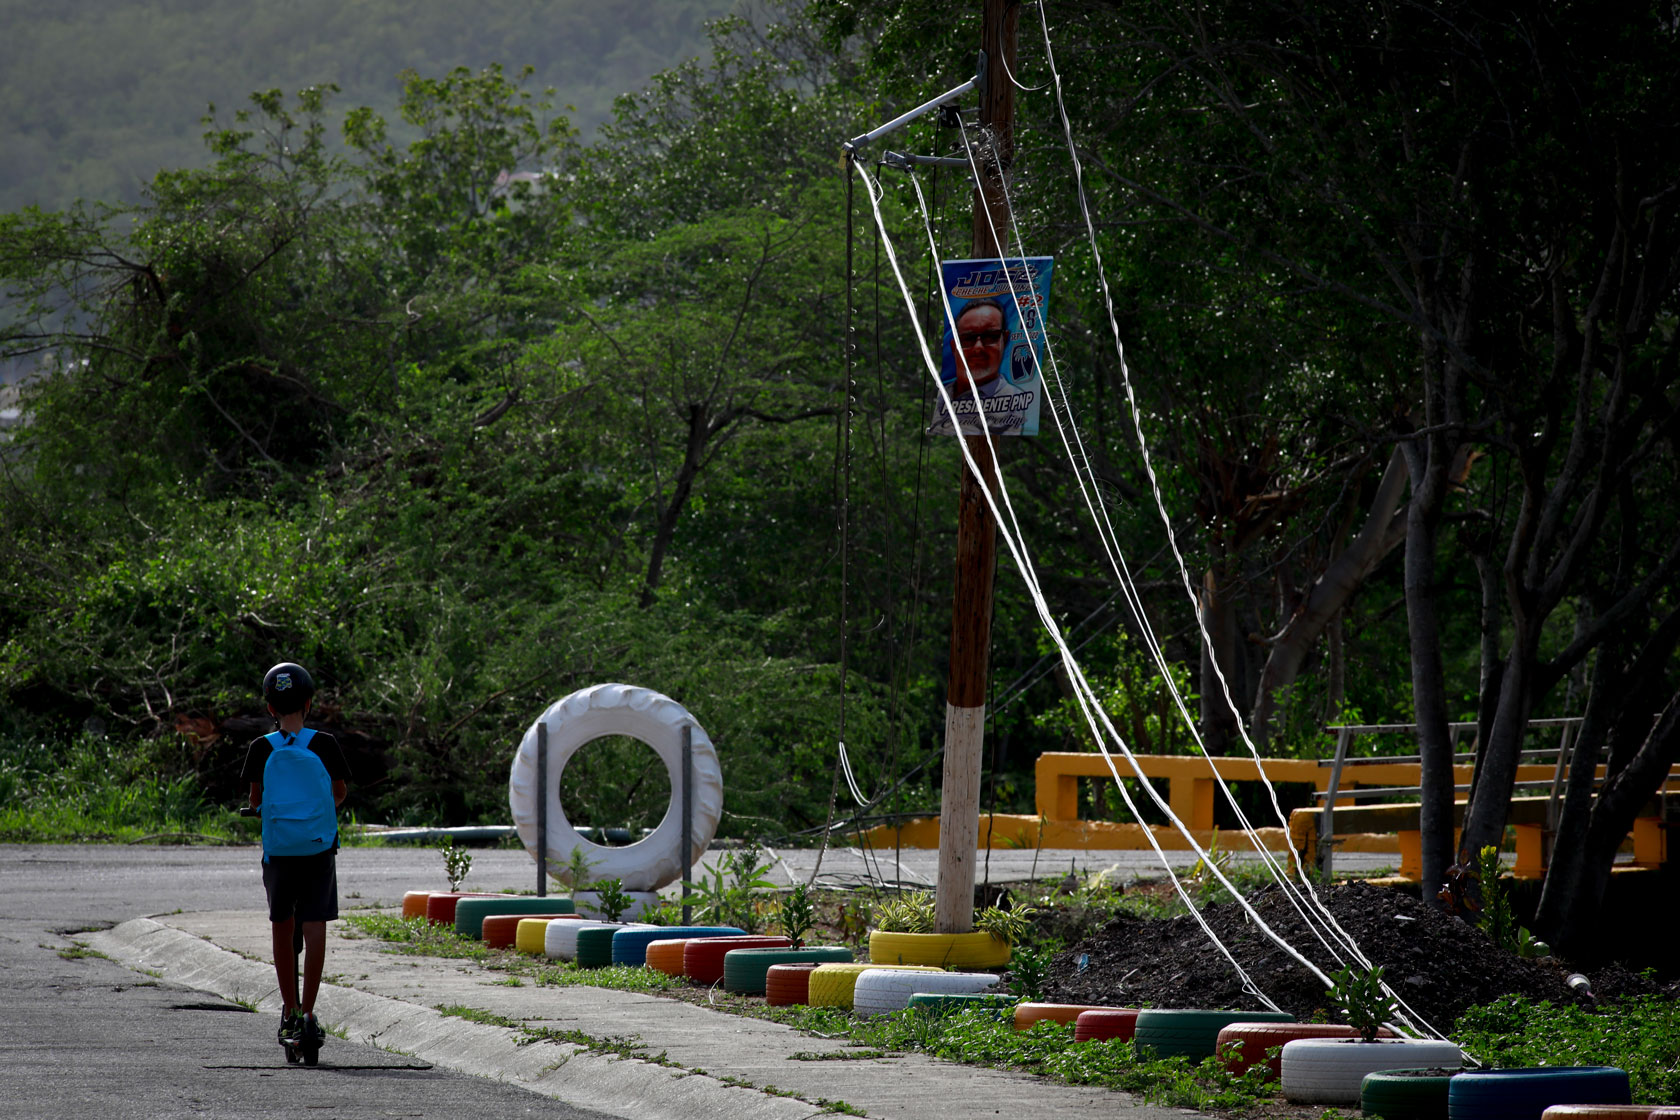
[0,0,1680,953]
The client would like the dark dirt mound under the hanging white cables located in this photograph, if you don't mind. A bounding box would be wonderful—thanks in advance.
[1045,882,1660,1031]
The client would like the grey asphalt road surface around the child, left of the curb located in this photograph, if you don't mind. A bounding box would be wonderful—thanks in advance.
[0,846,606,1120]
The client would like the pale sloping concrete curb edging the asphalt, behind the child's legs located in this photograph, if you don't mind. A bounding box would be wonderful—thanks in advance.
[86,919,825,1120]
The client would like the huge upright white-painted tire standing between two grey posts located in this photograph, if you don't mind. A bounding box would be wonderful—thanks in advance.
[507,685,724,892]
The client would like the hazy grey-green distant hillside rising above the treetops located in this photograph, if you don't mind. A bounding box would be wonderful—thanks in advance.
[0,0,732,210]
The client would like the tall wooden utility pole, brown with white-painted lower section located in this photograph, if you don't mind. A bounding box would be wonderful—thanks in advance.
[934,0,1020,934]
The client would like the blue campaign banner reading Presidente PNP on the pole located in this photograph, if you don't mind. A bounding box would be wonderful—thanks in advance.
[927,257,1055,435]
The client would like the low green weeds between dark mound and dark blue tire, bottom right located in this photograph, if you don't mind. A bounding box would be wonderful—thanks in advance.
[1453,996,1680,1105]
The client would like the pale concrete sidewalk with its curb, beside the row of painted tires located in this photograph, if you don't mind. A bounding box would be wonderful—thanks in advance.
[86,910,1194,1120]
